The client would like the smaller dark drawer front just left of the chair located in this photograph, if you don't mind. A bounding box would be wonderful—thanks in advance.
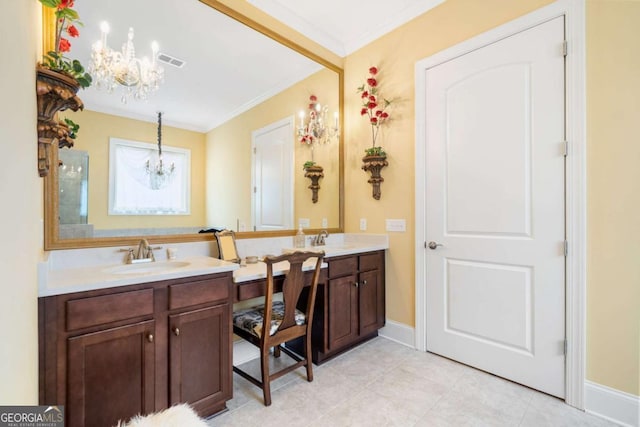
[169,276,231,310]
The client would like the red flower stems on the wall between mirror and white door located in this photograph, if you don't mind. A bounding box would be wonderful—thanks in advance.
[358,67,391,156]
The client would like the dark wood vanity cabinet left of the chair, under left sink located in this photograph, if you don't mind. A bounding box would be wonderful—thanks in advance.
[39,273,233,427]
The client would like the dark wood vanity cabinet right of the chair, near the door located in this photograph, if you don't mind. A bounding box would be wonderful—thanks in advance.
[312,251,385,363]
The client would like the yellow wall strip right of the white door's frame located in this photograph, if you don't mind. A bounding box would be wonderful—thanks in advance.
[587,0,640,395]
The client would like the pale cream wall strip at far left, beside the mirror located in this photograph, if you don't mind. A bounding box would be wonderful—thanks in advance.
[0,0,43,405]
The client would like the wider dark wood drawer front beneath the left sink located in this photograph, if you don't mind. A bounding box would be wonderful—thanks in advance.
[67,289,153,331]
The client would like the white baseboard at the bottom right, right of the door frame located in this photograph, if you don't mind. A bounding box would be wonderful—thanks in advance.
[584,381,640,427]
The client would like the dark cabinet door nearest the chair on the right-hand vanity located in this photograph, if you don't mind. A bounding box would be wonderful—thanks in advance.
[329,275,358,350]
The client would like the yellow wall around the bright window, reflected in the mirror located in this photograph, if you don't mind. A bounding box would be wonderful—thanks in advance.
[62,110,206,230]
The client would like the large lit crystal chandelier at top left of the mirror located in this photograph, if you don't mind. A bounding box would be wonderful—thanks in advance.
[88,22,164,104]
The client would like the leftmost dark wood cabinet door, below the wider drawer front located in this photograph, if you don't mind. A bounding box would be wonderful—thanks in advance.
[66,320,155,427]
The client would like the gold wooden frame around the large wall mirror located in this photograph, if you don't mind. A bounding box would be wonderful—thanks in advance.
[43,0,344,251]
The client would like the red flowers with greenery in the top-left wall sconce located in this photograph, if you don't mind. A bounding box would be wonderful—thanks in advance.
[39,0,91,88]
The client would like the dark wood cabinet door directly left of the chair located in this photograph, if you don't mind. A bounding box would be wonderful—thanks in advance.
[169,304,232,415]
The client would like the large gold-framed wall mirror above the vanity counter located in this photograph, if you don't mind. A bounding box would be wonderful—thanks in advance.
[45,0,343,250]
